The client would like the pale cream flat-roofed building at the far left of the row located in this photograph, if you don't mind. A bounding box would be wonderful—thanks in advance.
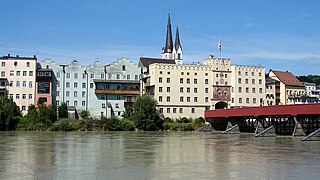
[0,54,37,114]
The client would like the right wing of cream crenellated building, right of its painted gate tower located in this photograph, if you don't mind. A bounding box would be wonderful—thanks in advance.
[230,65,266,108]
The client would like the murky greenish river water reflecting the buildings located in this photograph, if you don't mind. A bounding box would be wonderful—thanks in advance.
[0,132,320,180]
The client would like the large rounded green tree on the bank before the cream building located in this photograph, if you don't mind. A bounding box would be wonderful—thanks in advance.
[133,94,162,131]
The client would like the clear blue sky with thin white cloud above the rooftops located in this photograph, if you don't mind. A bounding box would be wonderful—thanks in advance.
[0,0,320,75]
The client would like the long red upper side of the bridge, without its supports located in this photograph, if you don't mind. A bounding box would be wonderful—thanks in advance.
[204,104,320,119]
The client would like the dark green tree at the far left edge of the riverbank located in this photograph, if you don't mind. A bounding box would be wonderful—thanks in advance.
[0,96,21,131]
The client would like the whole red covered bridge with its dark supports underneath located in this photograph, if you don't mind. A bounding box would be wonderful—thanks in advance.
[205,104,320,135]
